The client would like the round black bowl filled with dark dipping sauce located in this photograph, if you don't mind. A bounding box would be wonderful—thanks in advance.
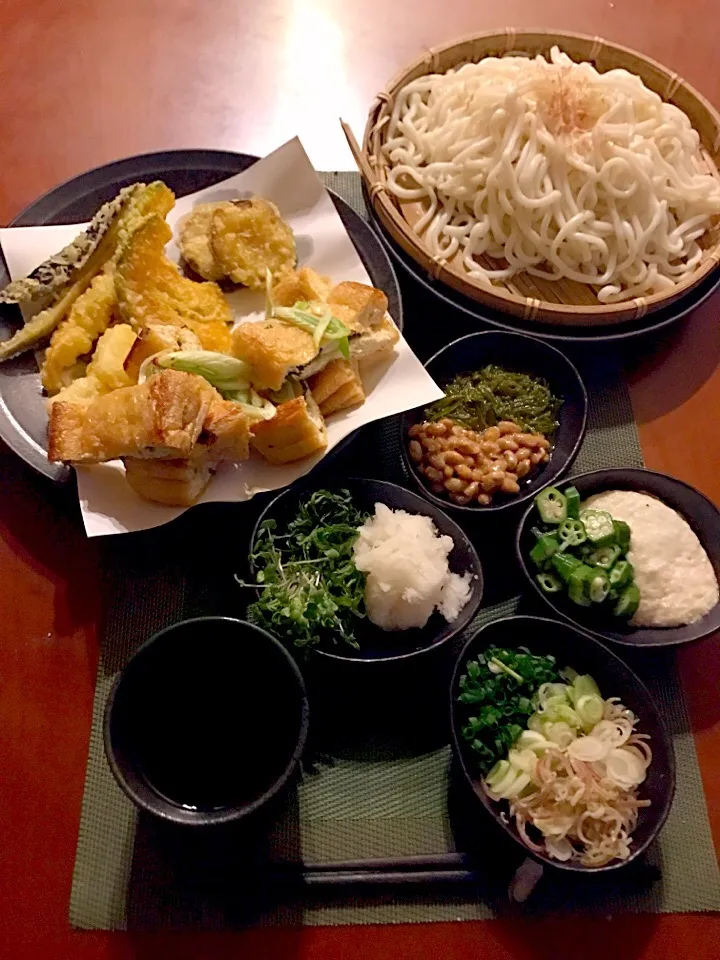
[104,617,308,826]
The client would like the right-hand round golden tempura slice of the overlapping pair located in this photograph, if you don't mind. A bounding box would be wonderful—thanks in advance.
[210,197,296,290]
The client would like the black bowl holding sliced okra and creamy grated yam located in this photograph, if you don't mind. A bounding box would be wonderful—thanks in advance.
[515,467,720,647]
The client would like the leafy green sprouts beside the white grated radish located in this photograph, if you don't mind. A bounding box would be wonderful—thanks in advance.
[243,490,368,648]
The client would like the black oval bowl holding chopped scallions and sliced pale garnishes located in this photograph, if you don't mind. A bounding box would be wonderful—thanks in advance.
[450,617,675,874]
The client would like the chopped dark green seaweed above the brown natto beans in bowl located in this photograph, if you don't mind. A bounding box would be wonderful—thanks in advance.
[425,364,563,439]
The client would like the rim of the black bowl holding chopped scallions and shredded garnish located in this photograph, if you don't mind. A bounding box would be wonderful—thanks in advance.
[449,614,677,876]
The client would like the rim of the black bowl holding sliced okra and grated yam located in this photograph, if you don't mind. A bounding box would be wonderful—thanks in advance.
[515,467,720,650]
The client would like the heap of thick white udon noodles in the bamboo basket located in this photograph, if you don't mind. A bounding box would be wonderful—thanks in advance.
[383,47,720,303]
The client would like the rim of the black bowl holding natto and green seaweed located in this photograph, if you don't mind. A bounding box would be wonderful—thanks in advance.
[400,330,588,517]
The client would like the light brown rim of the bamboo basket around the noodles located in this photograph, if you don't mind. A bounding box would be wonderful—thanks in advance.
[343,27,720,325]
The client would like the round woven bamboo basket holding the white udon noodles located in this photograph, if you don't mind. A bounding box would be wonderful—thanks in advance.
[343,29,720,326]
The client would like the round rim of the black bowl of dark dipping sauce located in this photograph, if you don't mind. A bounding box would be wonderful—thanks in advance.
[103,616,310,827]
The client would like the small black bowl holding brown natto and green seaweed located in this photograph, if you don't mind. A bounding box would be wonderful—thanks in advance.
[402,333,588,520]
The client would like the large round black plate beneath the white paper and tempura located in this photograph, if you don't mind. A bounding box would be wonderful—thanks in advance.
[0,150,403,482]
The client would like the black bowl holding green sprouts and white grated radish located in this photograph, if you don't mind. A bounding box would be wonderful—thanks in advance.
[250,478,483,666]
